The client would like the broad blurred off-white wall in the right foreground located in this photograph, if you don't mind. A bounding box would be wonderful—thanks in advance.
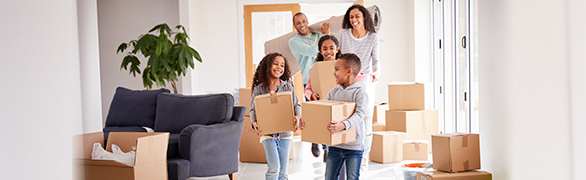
[478,0,572,180]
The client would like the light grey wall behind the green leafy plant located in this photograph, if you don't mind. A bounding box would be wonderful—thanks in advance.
[97,0,182,124]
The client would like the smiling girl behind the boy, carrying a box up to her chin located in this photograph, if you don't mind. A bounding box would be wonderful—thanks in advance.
[305,35,341,162]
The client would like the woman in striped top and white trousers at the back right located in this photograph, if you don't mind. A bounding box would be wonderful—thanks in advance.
[338,5,380,170]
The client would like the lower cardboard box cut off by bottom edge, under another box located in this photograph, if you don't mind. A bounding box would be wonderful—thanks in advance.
[417,170,492,180]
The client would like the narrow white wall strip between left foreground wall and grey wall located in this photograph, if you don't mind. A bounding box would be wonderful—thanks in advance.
[75,0,102,134]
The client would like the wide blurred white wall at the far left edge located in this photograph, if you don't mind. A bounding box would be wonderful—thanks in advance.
[0,0,82,179]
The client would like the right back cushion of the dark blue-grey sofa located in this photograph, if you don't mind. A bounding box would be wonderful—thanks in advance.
[155,93,234,133]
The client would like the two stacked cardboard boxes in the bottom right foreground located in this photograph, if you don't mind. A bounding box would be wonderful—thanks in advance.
[417,133,492,180]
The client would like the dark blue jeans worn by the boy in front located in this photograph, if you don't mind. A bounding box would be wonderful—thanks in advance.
[326,146,362,180]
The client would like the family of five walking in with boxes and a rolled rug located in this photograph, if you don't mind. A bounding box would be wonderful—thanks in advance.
[250,5,380,180]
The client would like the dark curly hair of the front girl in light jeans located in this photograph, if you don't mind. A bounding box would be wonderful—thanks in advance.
[252,52,291,91]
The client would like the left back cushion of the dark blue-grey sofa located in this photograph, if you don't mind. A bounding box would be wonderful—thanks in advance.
[106,87,169,128]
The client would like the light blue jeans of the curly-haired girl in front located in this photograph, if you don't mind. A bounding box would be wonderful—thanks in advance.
[262,138,291,180]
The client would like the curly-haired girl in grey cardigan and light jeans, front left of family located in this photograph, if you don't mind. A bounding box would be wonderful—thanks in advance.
[250,53,301,180]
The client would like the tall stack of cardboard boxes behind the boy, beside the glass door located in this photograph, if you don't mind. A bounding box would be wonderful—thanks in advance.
[370,83,438,163]
